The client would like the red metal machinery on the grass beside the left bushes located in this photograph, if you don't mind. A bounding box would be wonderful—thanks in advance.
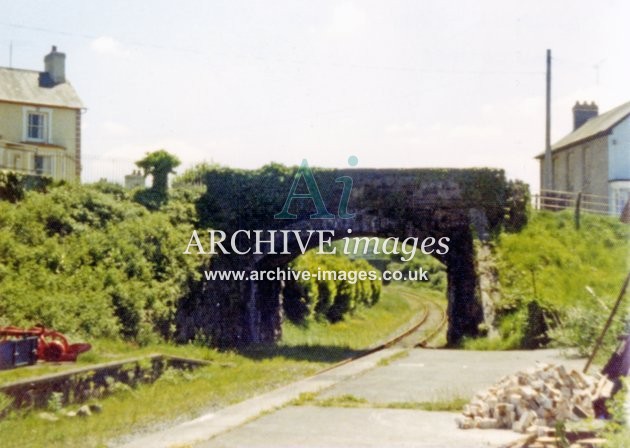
[0,326,92,363]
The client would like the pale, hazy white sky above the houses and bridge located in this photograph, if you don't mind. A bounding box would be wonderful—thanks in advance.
[0,0,630,191]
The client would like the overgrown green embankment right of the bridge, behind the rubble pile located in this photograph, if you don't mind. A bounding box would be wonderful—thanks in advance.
[478,211,630,354]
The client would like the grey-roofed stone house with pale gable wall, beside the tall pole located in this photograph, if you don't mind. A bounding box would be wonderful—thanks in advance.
[536,101,630,215]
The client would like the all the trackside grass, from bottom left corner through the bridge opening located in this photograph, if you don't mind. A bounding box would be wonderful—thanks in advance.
[0,285,434,448]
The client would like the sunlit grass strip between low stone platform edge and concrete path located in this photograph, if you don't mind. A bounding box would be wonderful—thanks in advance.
[0,352,321,448]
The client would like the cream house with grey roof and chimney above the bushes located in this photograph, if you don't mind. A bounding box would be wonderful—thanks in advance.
[0,47,85,182]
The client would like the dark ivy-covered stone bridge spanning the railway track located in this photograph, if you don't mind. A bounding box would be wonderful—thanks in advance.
[177,165,526,346]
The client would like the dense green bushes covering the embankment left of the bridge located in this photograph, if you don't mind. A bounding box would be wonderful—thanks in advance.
[0,185,199,342]
